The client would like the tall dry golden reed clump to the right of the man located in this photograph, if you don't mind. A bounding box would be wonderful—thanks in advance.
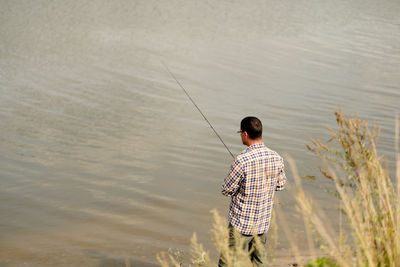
[291,110,400,266]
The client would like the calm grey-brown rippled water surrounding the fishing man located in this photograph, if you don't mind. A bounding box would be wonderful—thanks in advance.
[0,0,400,266]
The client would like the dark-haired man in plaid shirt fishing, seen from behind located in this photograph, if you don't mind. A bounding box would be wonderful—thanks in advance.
[218,117,286,267]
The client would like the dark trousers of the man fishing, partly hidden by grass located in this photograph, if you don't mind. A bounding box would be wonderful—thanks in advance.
[218,224,267,267]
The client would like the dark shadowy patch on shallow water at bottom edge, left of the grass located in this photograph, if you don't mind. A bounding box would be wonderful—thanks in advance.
[83,250,159,267]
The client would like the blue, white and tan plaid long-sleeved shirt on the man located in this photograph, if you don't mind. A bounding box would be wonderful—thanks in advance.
[222,143,286,235]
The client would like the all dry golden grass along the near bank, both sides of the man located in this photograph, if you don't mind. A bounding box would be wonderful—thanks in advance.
[157,110,400,267]
